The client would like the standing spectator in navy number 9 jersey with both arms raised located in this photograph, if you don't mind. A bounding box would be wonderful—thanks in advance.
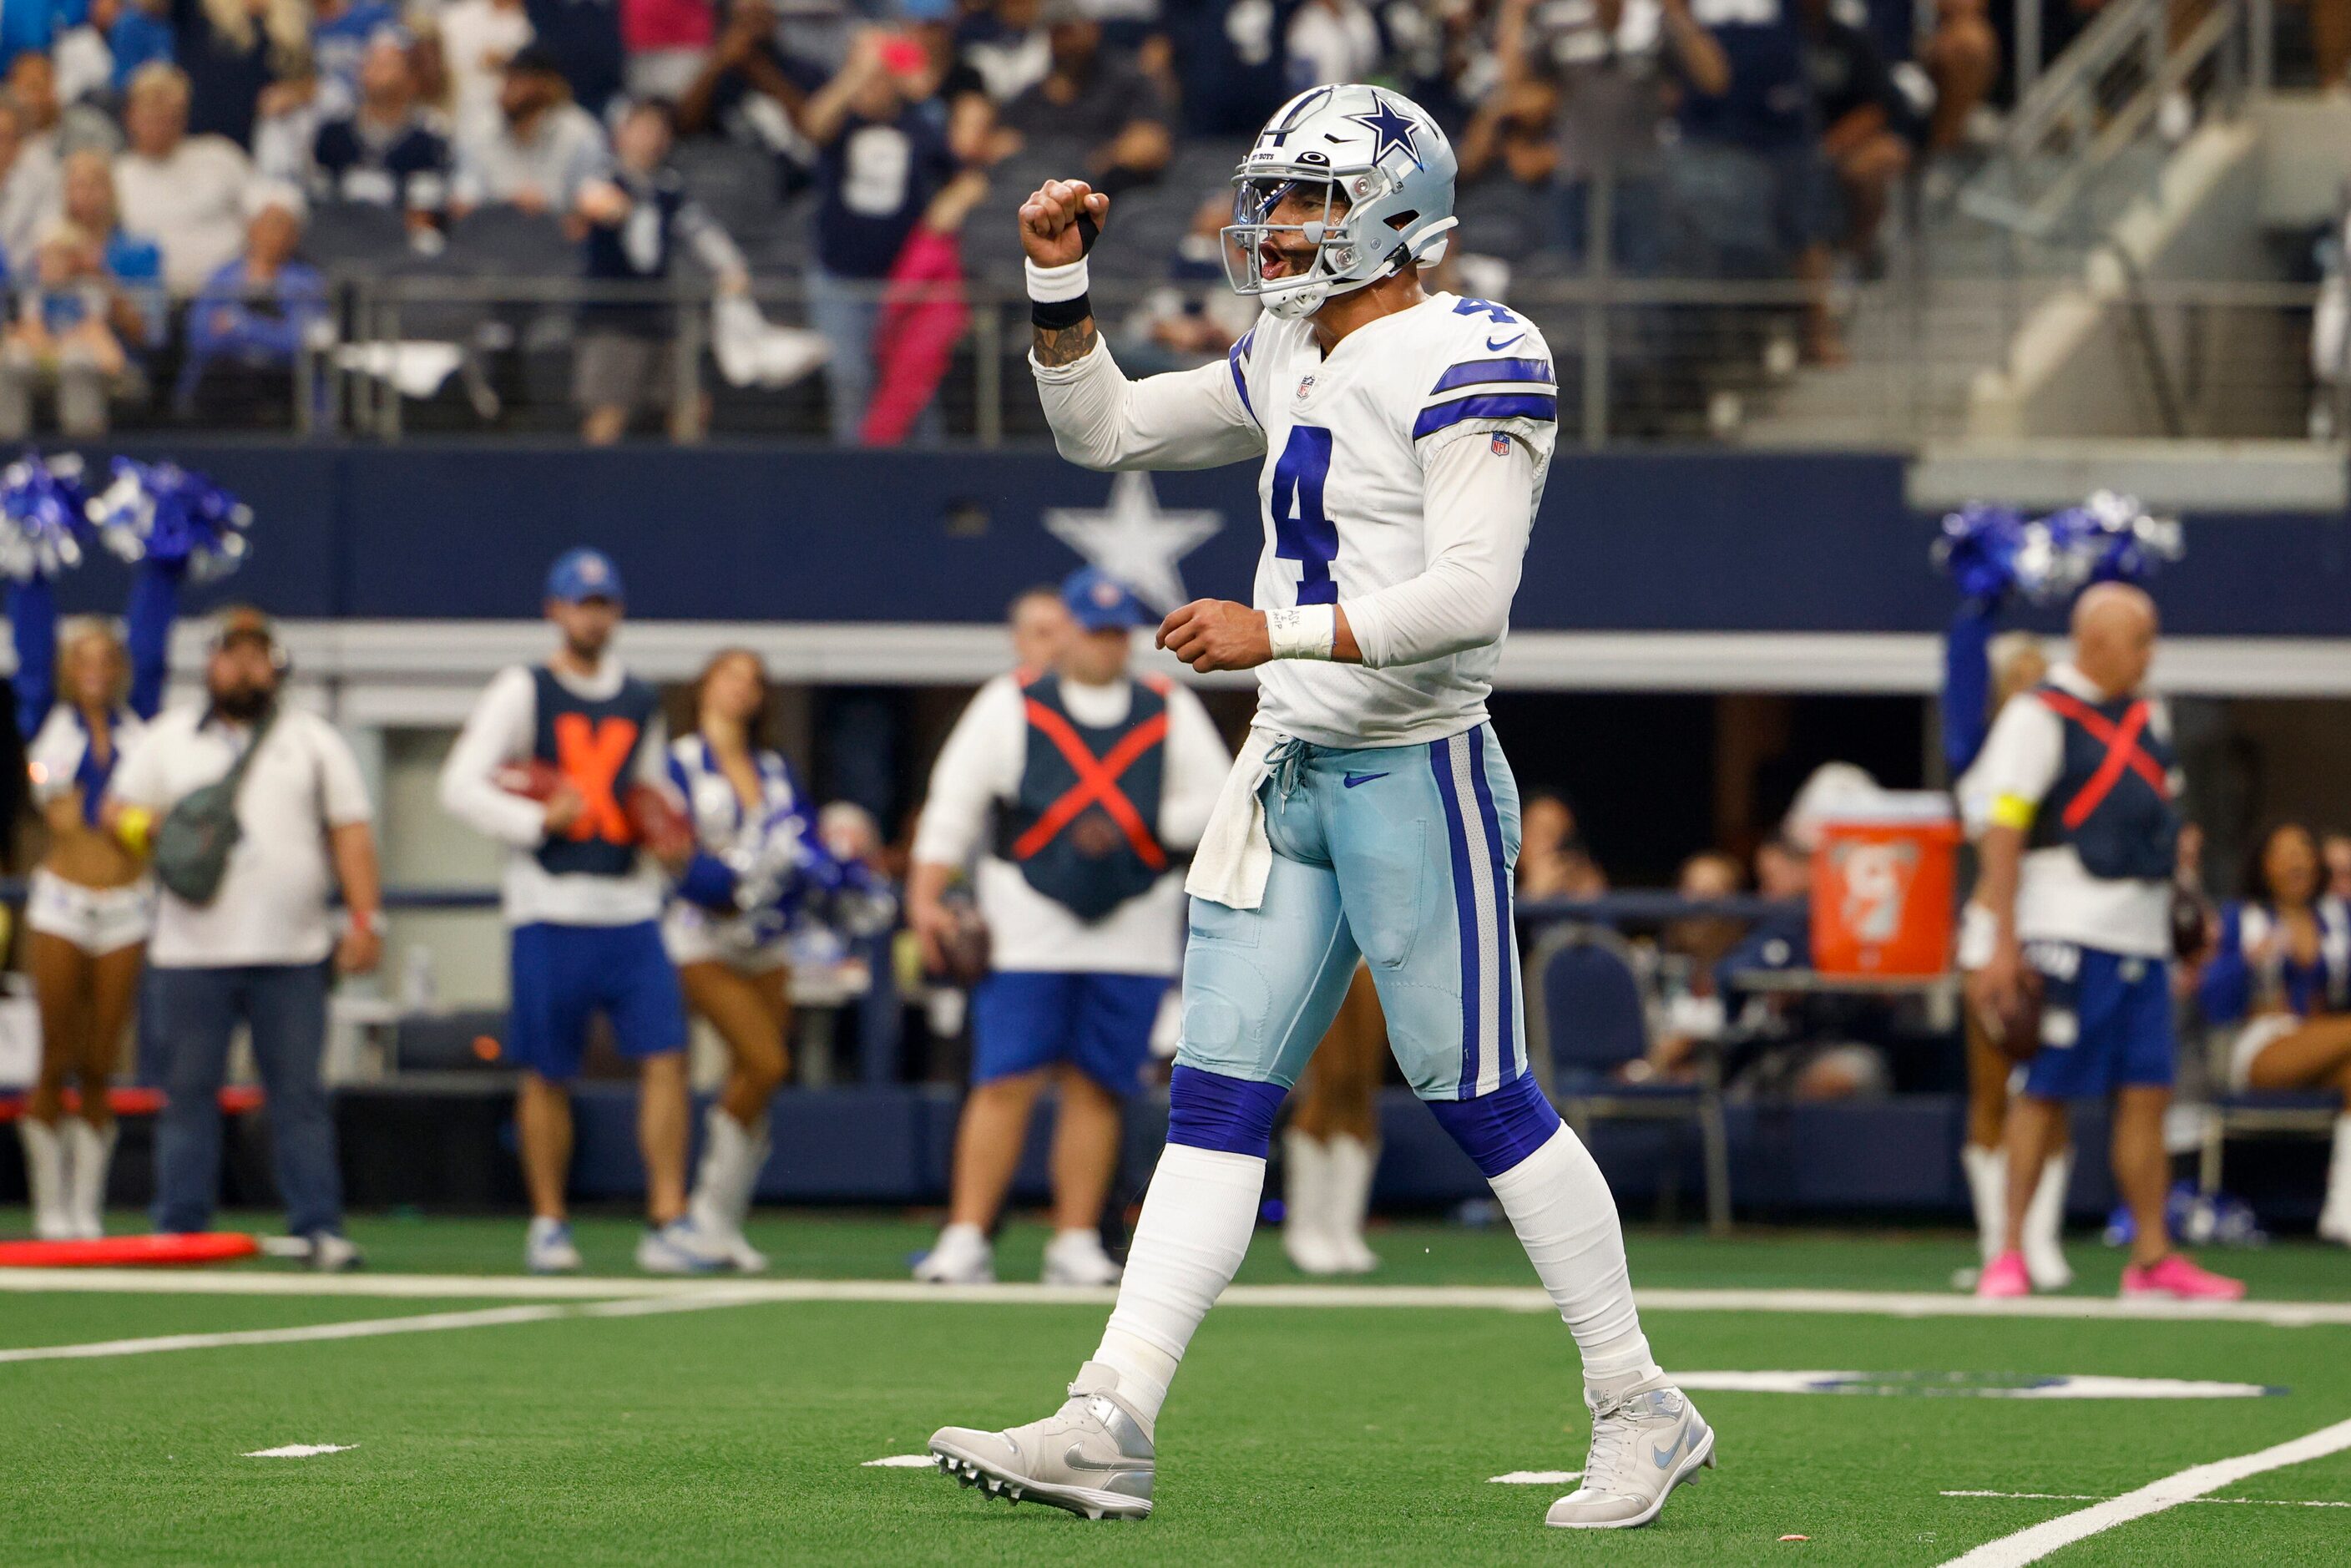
[801,31,954,444]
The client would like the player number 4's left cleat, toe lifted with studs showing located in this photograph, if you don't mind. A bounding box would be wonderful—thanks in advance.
[931,1361,1155,1519]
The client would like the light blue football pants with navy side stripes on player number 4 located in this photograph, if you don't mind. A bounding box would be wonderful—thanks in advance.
[1176,724,1526,1103]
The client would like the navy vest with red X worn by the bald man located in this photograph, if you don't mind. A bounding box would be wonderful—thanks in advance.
[2031,686,2179,882]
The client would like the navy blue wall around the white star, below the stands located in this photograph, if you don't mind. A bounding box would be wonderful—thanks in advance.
[45,442,2351,637]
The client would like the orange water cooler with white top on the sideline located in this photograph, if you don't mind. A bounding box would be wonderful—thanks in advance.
[1813,790,1961,975]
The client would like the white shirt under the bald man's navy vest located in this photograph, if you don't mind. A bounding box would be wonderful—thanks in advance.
[1956,663,2172,966]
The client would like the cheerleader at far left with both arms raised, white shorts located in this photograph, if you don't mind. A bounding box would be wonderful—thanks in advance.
[7,559,176,1242]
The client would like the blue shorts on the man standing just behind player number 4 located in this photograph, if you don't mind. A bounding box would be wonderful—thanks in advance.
[971,969,1169,1100]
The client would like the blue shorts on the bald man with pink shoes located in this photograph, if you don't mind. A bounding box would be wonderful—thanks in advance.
[2025,943,2177,1100]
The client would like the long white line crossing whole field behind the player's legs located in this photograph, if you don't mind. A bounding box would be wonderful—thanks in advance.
[0,1269,2351,1328]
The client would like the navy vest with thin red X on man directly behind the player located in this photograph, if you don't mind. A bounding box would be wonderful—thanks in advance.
[997,675,1169,919]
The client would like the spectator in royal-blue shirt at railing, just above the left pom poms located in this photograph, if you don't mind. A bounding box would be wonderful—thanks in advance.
[174,184,326,414]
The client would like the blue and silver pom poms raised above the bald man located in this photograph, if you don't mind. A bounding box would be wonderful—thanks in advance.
[1935,489,2182,604]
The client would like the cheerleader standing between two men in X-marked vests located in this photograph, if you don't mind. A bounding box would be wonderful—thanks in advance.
[663,649,887,1274]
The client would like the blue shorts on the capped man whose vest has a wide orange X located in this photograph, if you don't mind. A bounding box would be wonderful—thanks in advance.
[505,919,686,1079]
